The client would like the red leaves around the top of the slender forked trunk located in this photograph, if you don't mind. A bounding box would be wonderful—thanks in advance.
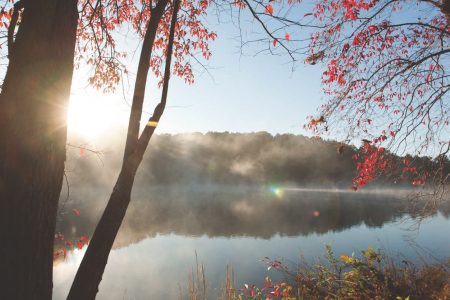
[77,0,217,91]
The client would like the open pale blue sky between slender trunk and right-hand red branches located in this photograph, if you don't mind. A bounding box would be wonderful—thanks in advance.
[160,27,322,133]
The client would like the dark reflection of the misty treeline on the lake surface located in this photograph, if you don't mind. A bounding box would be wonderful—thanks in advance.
[58,186,450,247]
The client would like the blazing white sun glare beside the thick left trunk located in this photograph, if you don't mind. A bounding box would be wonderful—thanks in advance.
[67,95,120,139]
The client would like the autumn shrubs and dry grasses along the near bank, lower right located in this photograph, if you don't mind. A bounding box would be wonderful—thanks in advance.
[186,246,450,300]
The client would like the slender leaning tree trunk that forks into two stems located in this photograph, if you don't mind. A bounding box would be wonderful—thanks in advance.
[67,0,180,300]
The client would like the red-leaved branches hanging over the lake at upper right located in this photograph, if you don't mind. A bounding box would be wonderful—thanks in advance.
[306,0,450,189]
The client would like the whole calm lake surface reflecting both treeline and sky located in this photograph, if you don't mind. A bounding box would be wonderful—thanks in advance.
[54,185,450,299]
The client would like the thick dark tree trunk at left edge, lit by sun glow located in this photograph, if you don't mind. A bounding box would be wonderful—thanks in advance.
[0,0,78,299]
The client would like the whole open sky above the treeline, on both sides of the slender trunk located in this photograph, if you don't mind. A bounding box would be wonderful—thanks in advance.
[69,4,323,143]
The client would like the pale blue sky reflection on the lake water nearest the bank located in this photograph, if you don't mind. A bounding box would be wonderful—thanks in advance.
[54,214,450,299]
